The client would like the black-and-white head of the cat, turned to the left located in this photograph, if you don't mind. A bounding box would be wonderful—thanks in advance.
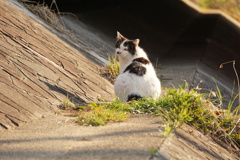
[115,32,140,58]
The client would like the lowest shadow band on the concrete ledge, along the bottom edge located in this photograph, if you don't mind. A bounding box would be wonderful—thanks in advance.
[0,148,157,160]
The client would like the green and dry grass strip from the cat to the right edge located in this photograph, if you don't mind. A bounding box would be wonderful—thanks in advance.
[159,86,240,151]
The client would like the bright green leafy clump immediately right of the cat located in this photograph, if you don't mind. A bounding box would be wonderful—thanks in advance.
[157,83,213,135]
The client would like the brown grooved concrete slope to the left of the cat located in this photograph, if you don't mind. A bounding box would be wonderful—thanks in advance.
[0,0,113,132]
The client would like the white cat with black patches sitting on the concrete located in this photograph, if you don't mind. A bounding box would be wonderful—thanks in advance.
[114,32,161,102]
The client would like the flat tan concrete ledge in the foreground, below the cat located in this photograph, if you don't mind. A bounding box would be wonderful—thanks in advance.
[0,116,161,160]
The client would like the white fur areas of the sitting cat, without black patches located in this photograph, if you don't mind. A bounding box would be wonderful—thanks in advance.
[114,39,161,101]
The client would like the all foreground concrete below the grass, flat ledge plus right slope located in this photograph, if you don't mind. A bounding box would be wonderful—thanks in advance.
[0,115,238,160]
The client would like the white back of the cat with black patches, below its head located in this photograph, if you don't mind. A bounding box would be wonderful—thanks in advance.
[114,57,161,101]
